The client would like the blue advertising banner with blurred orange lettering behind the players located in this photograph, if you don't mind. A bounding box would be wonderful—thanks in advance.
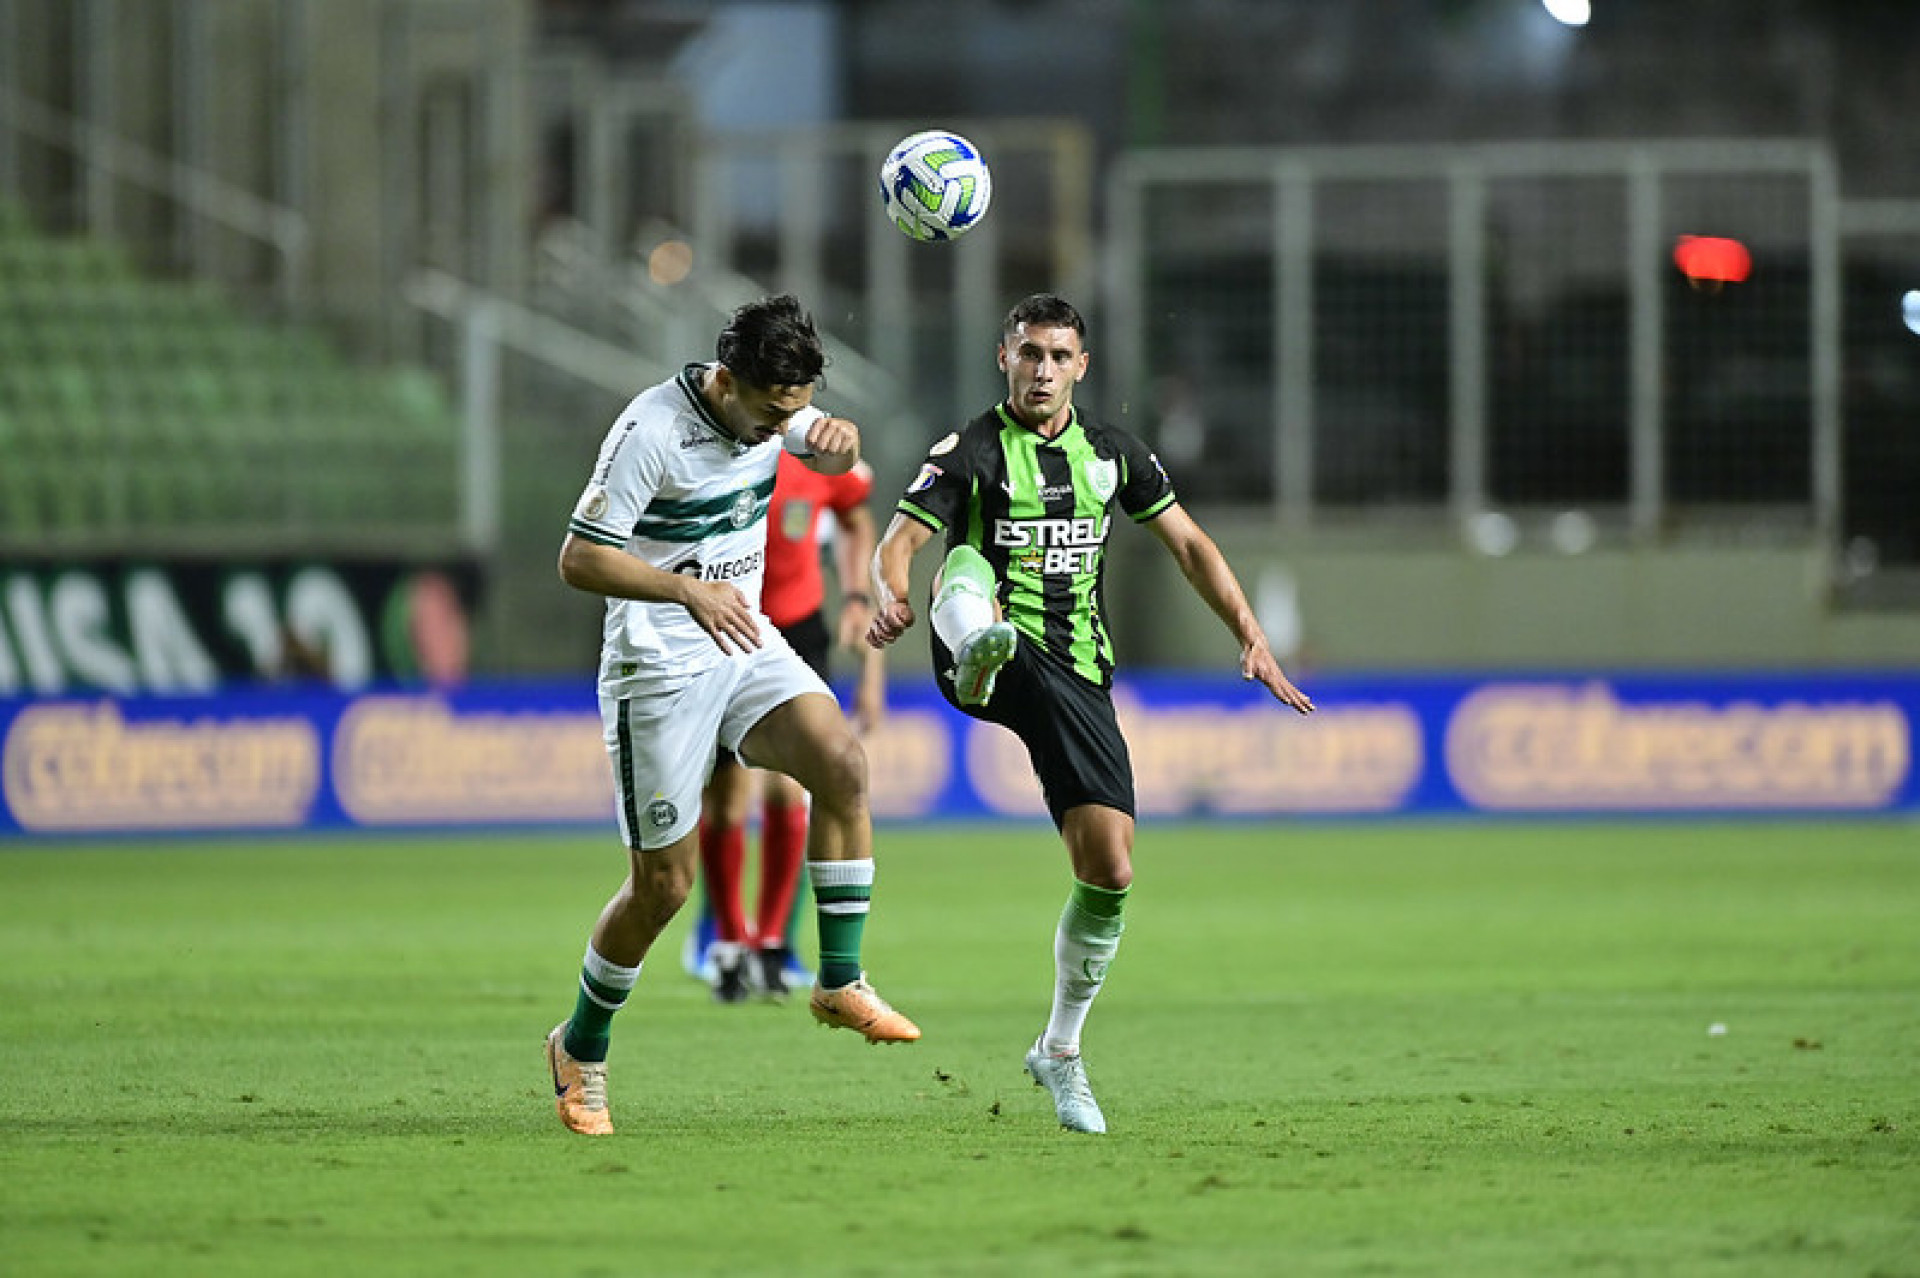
[0,674,1920,837]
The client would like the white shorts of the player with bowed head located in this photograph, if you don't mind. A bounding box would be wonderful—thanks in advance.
[601,629,833,850]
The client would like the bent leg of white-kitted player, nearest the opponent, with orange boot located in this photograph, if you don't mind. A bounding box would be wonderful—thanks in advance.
[741,693,920,1042]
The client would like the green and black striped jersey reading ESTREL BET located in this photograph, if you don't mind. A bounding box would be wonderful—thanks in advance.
[899,403,1173,687]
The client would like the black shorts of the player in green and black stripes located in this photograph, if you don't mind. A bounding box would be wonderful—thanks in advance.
[927,626,1133,829]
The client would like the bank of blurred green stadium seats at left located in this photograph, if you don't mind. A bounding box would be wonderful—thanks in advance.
[0,217,459,547]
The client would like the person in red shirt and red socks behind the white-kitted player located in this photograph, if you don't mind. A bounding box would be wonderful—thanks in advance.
[684,443,887,1004]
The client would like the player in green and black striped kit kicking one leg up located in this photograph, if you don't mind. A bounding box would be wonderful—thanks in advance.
[868,294,1313,1132]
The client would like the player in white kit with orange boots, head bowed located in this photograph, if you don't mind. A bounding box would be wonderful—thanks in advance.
[547,296,920,1136]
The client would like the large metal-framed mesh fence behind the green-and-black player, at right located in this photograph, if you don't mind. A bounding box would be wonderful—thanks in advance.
[1108,142,1866,549]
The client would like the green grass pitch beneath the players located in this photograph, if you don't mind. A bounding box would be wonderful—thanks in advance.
[0,823,1920,1278]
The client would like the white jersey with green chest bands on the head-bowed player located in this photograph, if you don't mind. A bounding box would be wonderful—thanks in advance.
[568,365,818,698]
